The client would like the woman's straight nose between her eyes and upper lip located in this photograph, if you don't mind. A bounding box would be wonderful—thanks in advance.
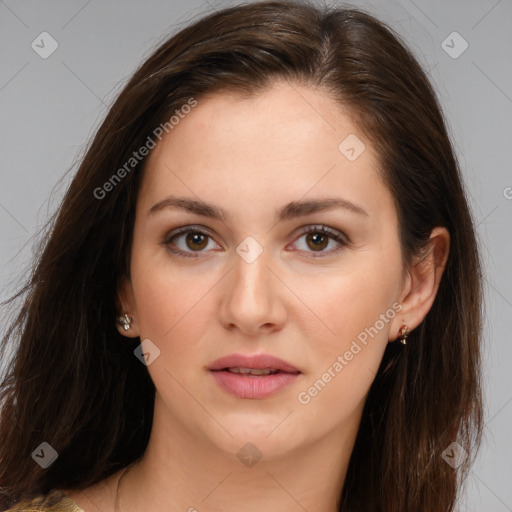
[220,240,287,335]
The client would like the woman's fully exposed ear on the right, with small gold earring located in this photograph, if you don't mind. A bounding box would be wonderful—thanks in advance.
[389,227,450,341]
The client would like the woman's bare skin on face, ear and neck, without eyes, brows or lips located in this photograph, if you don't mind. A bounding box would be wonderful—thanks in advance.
[60,83,449,512]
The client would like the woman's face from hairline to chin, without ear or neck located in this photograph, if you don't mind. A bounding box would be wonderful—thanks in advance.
[122,83,403,457]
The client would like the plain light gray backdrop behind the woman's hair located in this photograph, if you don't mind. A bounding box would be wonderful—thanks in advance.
[0,0,512,512]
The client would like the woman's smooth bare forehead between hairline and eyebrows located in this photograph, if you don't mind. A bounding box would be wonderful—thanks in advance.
[141,83,392,221]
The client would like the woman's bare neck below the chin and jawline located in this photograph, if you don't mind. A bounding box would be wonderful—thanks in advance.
[116,396,362,512]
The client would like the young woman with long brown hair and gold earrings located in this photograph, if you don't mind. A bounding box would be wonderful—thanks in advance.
[0,2,482,512]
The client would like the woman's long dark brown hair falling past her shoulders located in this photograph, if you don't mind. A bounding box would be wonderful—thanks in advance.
[0,1,482,512]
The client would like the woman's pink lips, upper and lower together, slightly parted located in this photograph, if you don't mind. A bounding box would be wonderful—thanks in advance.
[208,354,302,399]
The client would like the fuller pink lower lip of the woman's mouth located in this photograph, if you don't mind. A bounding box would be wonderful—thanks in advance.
[211,370,300,399]
